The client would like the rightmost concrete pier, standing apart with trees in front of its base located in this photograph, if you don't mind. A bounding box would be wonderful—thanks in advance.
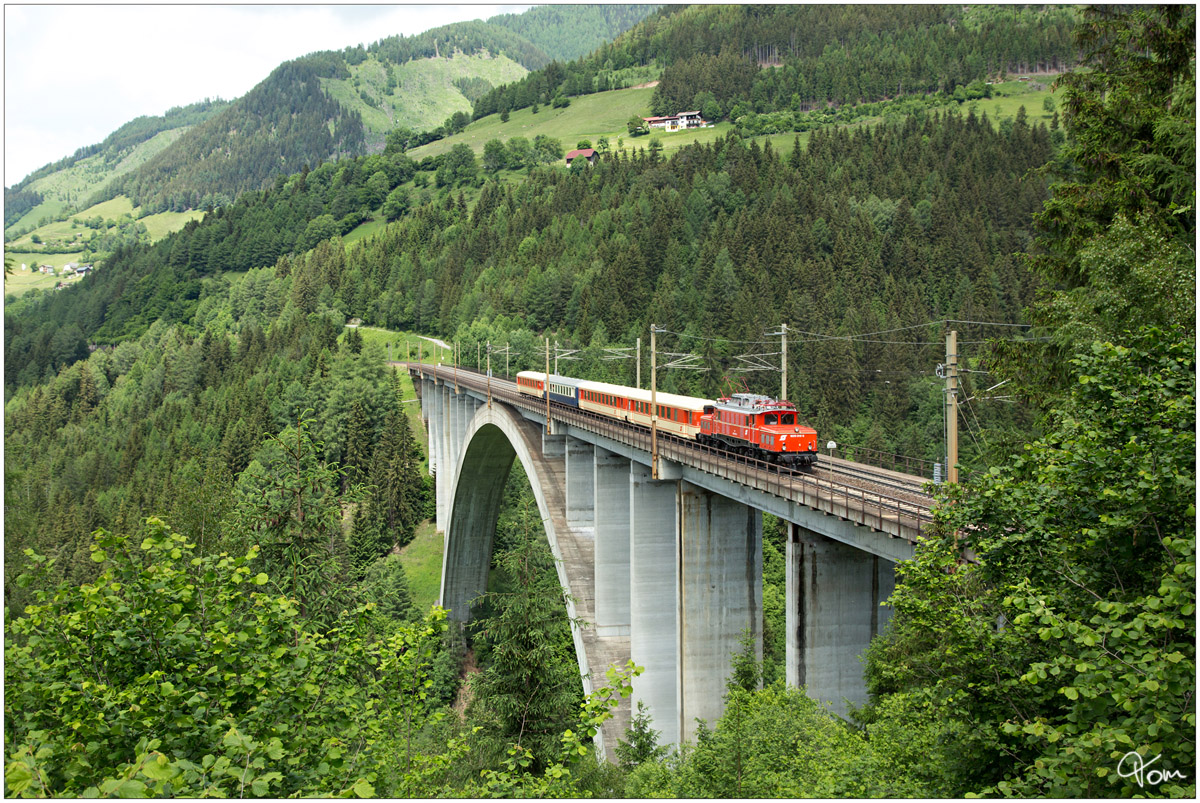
[786,525,895,717]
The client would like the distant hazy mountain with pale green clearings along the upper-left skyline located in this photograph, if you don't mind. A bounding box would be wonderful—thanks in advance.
[5,6,652,225]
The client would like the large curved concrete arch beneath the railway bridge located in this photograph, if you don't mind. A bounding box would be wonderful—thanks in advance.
[442,402,606,720]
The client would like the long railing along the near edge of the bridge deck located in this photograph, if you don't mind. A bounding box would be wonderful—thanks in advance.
[417,366,932,543]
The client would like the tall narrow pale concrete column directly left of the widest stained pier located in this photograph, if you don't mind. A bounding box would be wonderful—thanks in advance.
[629,463,682,744]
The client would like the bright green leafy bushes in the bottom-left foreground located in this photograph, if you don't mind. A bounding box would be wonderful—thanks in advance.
[5,519,444,797]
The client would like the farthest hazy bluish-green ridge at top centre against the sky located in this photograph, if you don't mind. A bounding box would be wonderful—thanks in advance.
[487,5,658,63]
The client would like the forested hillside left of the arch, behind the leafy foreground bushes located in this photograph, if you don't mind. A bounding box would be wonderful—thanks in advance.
[5,262,426,601]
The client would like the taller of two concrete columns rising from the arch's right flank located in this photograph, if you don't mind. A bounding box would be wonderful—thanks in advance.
[592,447,630,633]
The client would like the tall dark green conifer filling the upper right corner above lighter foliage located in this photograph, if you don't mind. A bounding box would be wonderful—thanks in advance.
[1000,6,1196,398]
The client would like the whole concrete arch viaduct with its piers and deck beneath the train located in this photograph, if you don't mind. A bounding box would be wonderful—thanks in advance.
[407,364,929,755]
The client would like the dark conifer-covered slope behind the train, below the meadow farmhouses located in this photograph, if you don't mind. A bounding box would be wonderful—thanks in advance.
[343,115,1050,457]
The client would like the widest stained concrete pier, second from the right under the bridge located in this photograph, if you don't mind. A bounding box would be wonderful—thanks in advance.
[679,483,762,741]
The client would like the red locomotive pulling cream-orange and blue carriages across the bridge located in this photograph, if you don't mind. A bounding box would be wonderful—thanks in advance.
[517,371,817,467]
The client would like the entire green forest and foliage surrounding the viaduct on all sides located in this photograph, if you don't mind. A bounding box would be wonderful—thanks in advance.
[4,6,1196,798]
